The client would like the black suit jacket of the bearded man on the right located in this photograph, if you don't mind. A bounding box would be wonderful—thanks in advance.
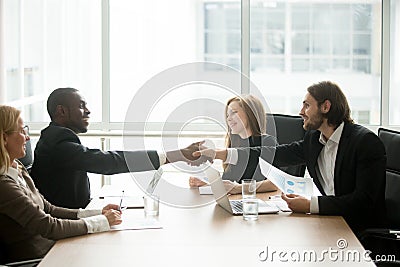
[236,123,386,232]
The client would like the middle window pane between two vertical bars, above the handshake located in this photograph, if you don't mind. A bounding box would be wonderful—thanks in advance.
[110,0,240,122]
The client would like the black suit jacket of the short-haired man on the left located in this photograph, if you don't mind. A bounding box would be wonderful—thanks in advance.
[31,123,160,208]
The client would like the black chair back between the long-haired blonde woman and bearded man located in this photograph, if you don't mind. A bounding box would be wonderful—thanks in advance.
[267,113,306,177]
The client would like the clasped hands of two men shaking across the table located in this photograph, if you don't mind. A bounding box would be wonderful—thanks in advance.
[162,141,227,166]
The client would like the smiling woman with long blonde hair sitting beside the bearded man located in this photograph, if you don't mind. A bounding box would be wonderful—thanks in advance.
[189,95,278,194]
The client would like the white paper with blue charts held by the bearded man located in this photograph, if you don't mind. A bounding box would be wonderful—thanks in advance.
[259,158,321,197]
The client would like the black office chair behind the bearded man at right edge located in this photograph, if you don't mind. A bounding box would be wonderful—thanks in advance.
[360,128,400,266]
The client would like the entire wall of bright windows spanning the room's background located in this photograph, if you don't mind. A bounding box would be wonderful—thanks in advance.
[1,0,394,129]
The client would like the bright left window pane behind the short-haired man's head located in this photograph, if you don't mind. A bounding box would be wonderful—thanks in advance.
[3,0,102,122]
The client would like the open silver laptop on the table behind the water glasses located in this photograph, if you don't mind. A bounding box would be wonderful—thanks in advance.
[204,166,279,215]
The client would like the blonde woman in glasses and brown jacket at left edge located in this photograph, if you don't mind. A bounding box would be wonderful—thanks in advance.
[0,105,122,262]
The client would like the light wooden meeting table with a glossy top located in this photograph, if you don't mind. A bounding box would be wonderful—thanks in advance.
[39,172,375,267]
